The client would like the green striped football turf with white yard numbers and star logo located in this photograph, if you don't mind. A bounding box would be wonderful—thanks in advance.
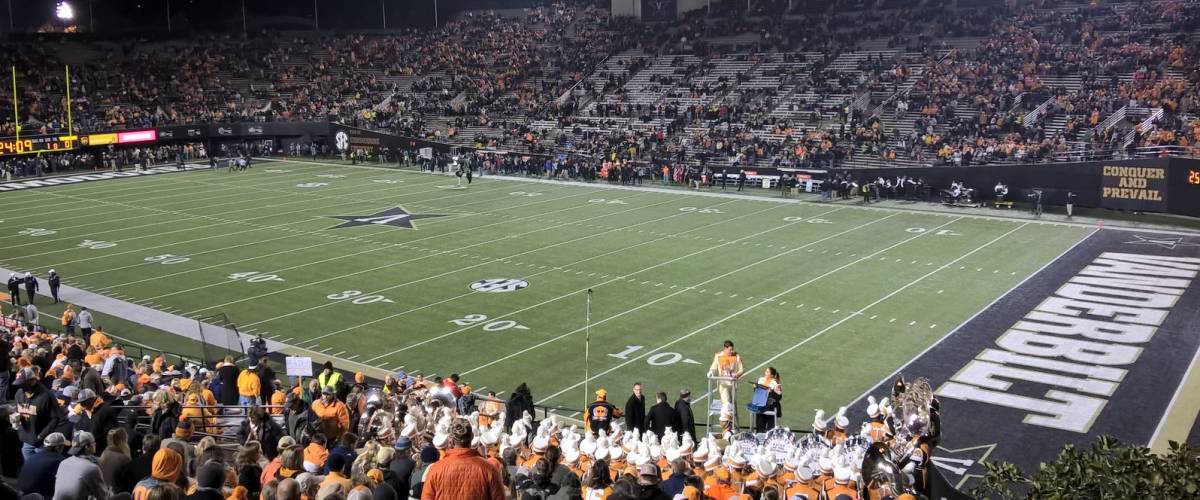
[0,162,1091,427]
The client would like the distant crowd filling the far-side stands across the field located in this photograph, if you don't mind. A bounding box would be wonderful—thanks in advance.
[0,0,1200,169]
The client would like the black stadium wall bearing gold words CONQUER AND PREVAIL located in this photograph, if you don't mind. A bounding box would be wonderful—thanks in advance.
[834,158,1200,216]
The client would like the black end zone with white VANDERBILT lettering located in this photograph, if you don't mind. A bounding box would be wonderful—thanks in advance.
[856,229,1200,487]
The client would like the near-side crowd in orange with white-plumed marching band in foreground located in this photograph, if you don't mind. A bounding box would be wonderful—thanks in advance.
[0,299,937,500]
